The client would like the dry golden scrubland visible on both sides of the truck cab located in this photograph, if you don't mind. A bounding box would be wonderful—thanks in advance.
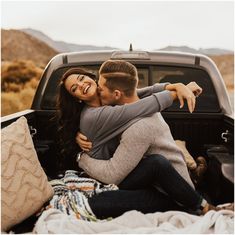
[1,55,234,116]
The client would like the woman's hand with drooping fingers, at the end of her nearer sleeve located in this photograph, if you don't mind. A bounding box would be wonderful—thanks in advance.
[165,83,196,113]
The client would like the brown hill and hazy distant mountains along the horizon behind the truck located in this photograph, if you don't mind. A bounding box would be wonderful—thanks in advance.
[1,29,233,69]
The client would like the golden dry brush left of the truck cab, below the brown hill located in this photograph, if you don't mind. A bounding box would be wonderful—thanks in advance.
[1,60,43,116]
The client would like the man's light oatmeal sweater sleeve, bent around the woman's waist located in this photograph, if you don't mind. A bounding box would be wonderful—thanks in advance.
[79,119,154,185]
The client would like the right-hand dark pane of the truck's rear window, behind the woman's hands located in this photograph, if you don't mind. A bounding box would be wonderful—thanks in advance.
[151,66,220,113]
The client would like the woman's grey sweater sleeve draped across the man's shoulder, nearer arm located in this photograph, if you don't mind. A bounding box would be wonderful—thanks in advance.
[80,91,173,142]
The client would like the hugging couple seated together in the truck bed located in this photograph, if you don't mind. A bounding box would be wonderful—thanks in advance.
[57,60,233,218]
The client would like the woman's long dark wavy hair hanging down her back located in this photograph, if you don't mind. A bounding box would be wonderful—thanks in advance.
[56,67,96,169]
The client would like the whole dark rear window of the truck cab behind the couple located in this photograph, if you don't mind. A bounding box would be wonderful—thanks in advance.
[42,65,220,113]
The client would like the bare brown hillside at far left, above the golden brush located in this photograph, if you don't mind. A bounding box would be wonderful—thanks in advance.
[1,29,58,67]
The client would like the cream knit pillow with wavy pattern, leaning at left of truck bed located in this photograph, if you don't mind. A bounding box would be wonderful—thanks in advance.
[1,117,53,231]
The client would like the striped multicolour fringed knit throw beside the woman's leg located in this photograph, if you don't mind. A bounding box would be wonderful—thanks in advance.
[49,170,118,221]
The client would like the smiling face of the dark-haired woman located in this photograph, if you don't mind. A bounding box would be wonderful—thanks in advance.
[64,74,97,101]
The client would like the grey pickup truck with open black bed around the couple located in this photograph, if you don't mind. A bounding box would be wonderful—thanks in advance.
[1,51,234,231]
